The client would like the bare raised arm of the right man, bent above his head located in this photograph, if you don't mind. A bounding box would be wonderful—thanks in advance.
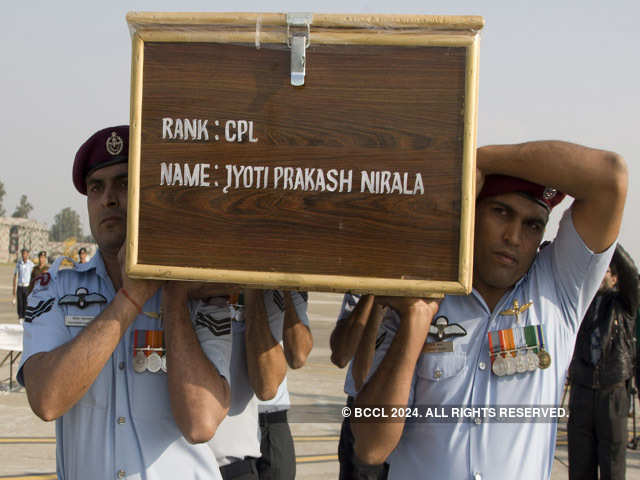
[477,141,627,253]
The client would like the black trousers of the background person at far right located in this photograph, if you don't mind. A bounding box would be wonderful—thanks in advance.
[568,383,629,480]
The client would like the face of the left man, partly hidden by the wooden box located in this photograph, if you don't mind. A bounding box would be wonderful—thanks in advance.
[87,163,128,253]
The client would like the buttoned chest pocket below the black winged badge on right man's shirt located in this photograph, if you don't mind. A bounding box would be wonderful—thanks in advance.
[414,351,467,405]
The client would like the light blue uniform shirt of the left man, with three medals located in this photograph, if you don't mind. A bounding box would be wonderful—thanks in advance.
[18,255,231,480]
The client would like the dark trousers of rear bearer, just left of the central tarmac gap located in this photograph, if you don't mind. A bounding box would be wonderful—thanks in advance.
[256,410,296,480]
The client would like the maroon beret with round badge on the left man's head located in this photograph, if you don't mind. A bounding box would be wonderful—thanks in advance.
[73,125,129,195]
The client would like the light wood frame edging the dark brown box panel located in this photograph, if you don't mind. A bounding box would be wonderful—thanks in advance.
[126,12,484,297]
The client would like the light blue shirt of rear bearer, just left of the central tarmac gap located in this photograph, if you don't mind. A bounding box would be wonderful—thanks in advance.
[258,290,309,413]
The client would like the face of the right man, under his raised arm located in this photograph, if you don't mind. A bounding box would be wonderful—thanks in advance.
[473,193,549,296]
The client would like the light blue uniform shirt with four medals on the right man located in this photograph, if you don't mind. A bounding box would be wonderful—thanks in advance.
[374,211,615,480]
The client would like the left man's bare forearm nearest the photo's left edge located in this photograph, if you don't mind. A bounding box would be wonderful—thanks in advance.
[23,293,138,421]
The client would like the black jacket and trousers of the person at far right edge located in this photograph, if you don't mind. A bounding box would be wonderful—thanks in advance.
[568,245,638,480]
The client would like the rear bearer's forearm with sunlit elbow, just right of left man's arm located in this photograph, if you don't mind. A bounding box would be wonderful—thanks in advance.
[244,290,287,400]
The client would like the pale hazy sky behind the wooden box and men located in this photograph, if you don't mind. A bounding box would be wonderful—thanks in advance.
[0,0,640,261]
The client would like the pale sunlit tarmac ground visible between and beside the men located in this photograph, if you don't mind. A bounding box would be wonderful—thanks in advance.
[0,264,640,480]
